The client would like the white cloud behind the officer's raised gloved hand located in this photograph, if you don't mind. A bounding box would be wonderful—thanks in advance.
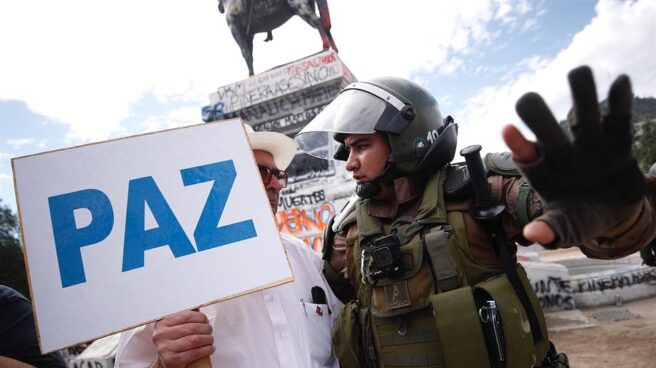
[456,1,656,151]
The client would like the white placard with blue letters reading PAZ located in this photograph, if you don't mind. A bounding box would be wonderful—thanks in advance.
[12,119,293,352]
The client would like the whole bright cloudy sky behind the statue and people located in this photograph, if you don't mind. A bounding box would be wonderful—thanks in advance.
[0,0,656,210]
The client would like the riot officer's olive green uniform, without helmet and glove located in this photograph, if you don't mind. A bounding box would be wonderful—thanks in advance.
[325,170,656,367]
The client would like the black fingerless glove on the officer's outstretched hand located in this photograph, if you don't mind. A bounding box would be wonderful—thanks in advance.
[516,66,645,243]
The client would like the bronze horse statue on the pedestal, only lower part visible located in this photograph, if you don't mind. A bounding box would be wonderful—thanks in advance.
[219,0,337,76]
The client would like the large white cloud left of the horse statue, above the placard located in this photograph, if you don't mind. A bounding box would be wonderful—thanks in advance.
[0,0,229,140]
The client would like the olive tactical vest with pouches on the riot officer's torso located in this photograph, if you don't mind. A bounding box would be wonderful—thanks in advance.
[333,170,549,368]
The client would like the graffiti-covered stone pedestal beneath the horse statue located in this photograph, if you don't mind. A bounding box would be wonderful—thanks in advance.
[203,50,356,251]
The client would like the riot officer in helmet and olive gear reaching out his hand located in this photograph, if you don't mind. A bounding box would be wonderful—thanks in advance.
[295,67,656,367]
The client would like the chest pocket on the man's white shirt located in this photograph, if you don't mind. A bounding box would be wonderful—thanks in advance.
[299,302,333,367]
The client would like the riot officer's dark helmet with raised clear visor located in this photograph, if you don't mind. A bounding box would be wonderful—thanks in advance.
[294,77,457,197]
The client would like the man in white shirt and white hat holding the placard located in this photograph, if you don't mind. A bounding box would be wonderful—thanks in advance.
[116,125,343,368]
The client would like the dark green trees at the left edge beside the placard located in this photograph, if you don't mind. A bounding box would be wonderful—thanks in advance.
[0,200,30,298]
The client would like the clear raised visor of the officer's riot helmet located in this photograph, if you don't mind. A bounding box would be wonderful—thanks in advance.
[294,89,399,159]
